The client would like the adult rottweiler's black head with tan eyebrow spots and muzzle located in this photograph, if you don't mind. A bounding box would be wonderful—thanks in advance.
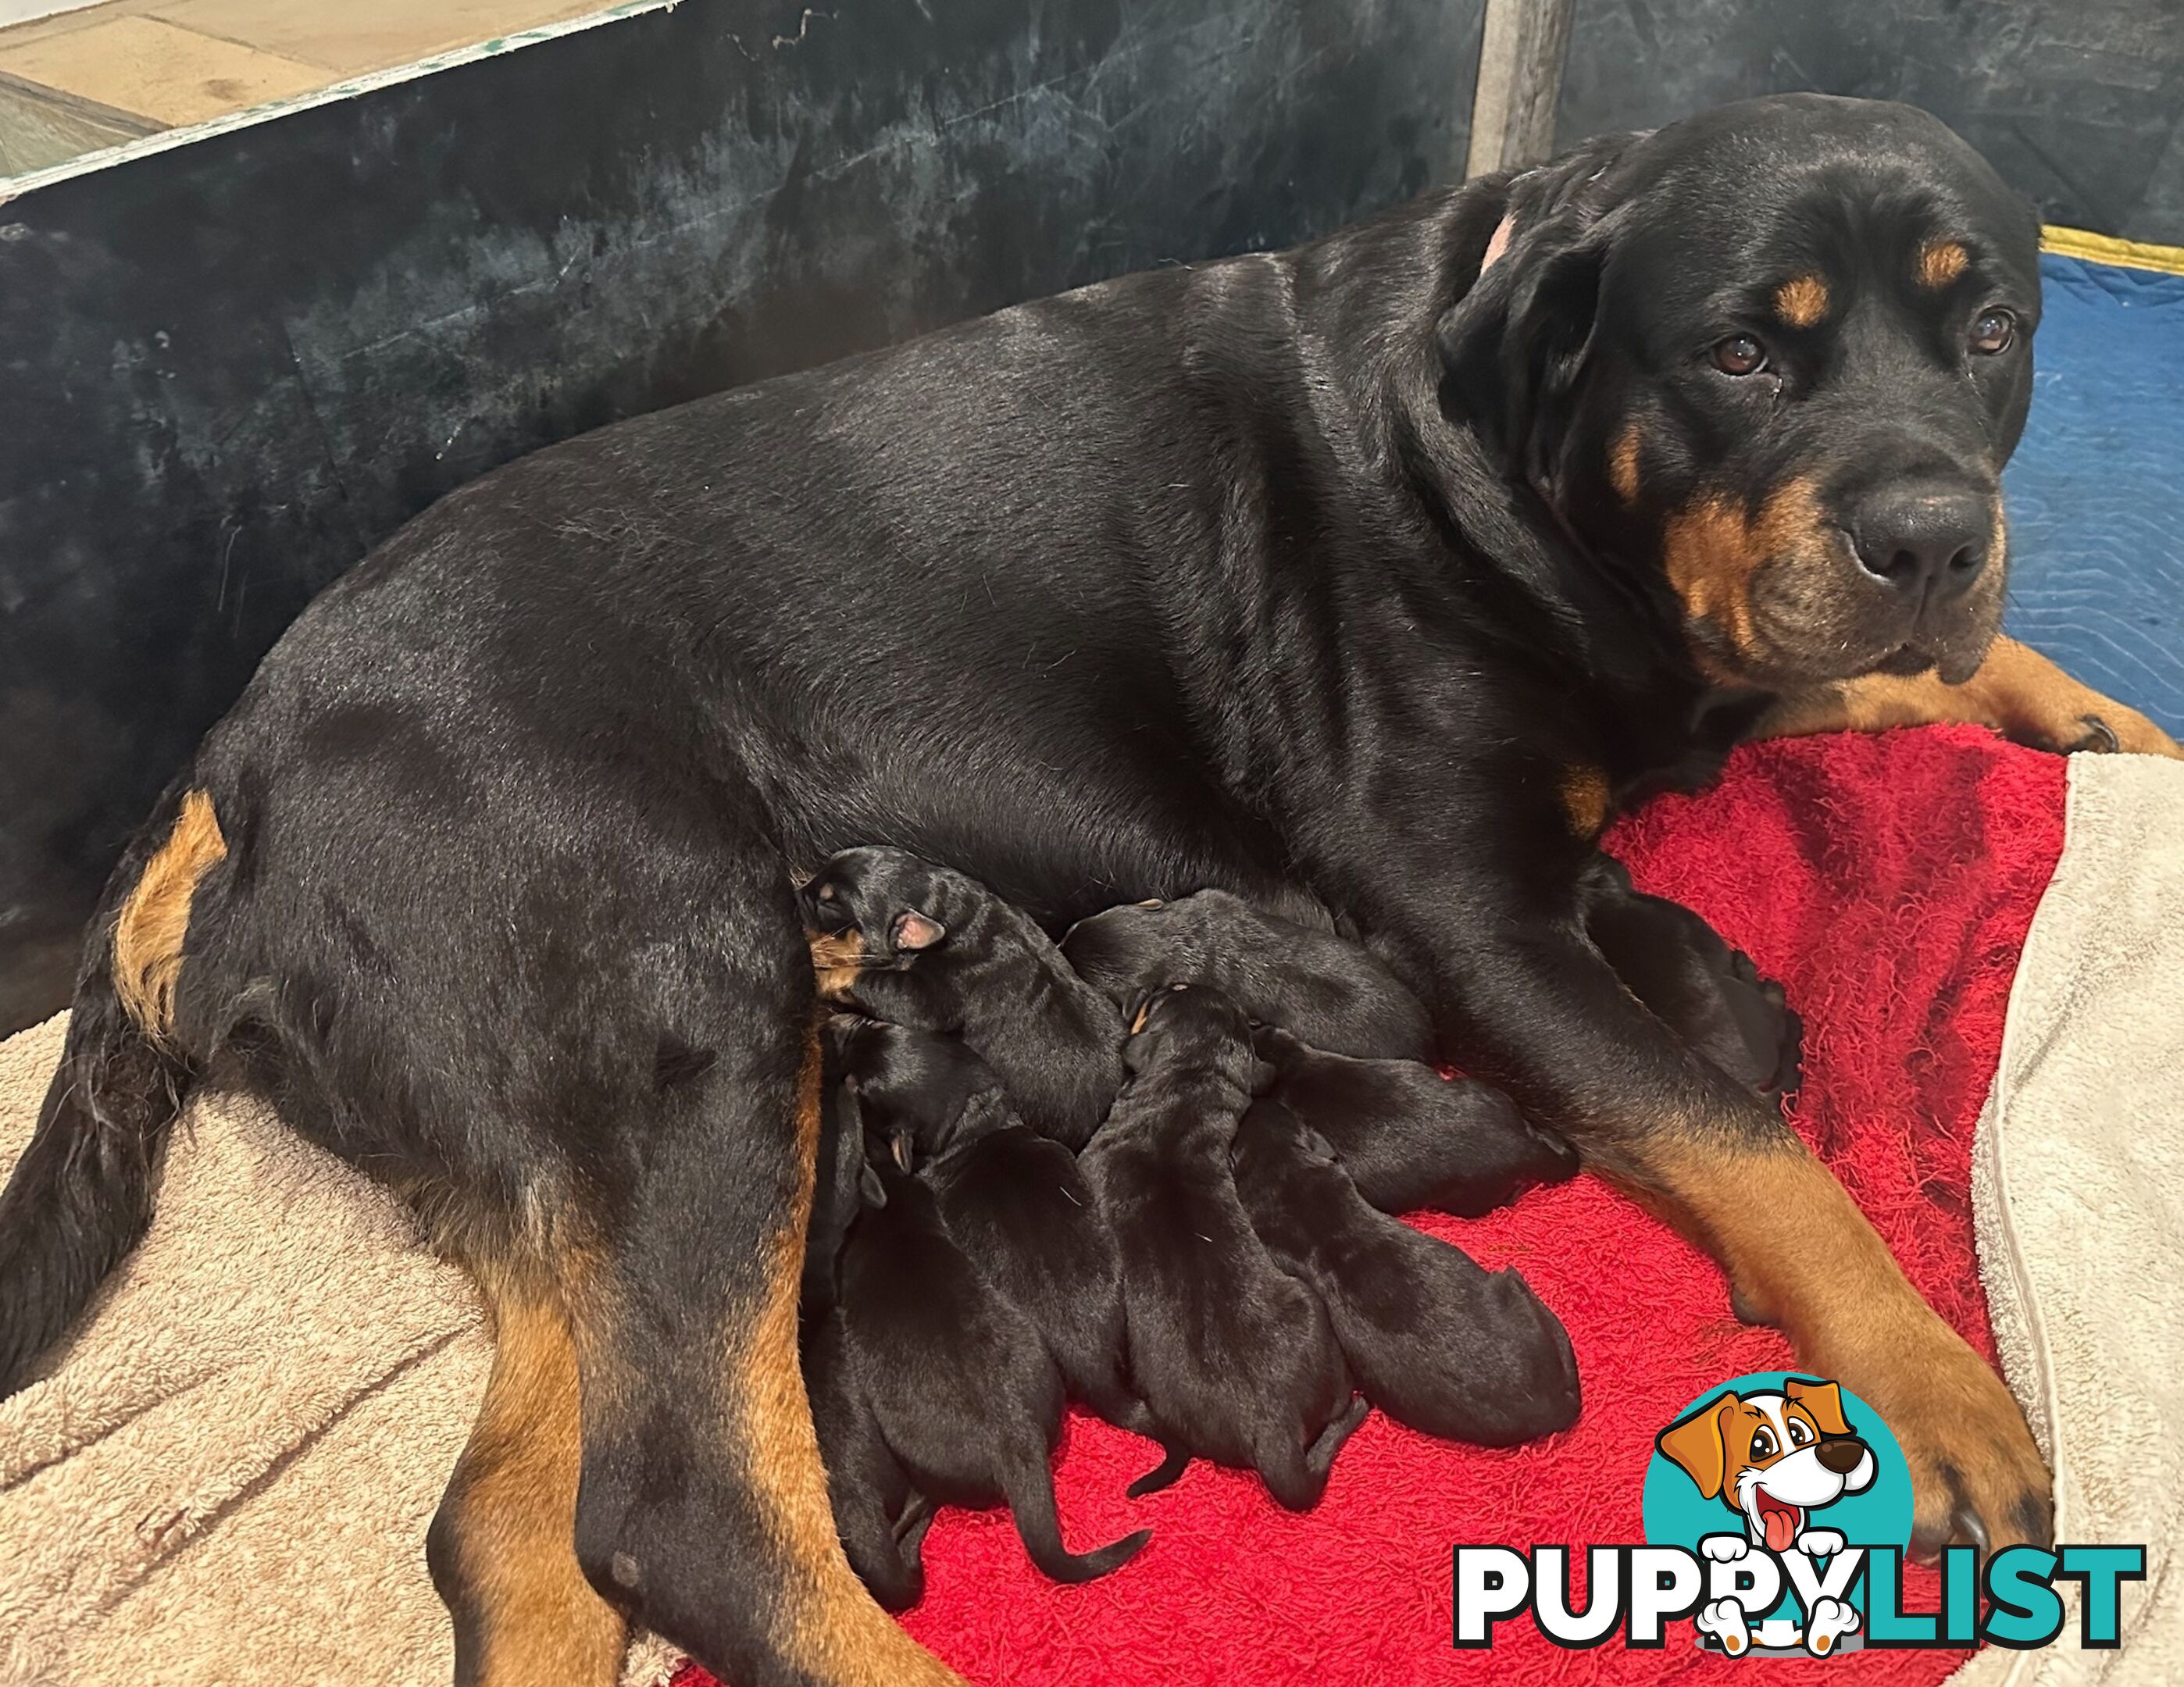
[1441,94,2039,690]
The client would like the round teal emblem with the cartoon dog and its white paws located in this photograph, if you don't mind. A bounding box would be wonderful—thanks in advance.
[1643,1371,1911,1657]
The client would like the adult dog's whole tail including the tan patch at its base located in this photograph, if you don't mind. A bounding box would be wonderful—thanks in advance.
[0,783,215,1399]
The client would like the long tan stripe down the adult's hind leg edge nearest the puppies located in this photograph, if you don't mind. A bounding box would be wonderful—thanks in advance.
[747,1025,963,1687]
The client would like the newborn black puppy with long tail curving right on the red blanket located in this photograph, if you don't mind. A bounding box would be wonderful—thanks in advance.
[840,1143,1151,1582]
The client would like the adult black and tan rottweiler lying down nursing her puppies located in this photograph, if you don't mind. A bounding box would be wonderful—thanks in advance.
[0,96,2179,1687]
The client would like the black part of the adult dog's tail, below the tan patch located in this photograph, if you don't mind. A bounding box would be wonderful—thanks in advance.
[0,969,186,1399]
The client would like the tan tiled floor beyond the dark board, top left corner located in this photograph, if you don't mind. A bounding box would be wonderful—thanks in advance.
[0,0,609,177]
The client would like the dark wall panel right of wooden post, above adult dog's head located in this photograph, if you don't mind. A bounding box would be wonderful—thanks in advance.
[1558,0,2184,244]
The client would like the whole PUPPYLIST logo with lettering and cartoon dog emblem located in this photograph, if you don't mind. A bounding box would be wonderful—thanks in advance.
[1454,1371,2147,1659]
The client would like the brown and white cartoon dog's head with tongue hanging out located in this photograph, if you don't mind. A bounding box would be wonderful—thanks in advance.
[1655,1377,1874,1556]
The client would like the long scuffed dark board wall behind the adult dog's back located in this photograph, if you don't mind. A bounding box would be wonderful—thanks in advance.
[0,0,1481,1033]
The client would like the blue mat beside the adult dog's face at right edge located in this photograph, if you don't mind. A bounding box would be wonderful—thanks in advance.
[2003,253,2184,736]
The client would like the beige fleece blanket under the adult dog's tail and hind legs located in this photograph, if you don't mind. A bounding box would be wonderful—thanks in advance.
[0,1015,675,1687]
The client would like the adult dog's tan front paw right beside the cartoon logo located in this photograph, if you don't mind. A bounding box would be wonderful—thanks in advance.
[1836,1307,2055,1556]
